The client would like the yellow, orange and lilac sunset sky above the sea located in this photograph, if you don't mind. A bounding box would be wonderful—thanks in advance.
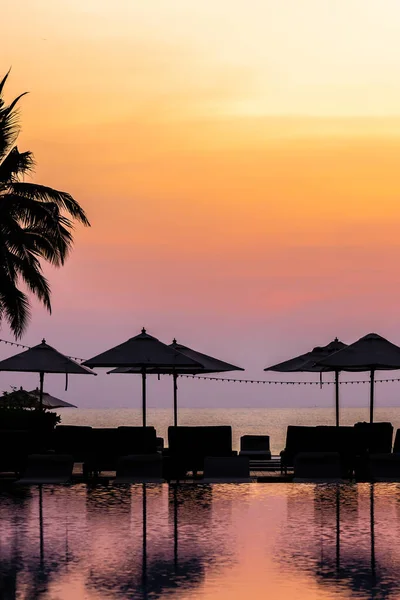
[0,0,400,406]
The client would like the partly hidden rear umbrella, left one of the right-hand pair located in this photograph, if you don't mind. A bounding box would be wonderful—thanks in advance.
[264,338,347,427]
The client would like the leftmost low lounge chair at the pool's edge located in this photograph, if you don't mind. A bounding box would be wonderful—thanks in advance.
[17,454,74,485]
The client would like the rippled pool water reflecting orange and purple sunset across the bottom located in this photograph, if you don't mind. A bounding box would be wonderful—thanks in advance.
[0,483,400,600]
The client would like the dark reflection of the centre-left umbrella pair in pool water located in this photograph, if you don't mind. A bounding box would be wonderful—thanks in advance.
[83,484,212,599]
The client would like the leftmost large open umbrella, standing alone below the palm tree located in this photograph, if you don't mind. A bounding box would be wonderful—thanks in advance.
[0,339,96,408]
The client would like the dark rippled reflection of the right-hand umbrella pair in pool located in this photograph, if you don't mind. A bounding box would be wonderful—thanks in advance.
[276,484,400,600]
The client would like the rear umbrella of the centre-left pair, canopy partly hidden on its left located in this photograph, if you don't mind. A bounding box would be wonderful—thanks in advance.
[109,339,244,427]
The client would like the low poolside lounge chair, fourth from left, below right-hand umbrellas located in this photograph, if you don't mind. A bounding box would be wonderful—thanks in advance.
[293,452,342,483]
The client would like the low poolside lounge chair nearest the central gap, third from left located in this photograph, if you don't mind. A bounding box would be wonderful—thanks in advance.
[203,456,252,483]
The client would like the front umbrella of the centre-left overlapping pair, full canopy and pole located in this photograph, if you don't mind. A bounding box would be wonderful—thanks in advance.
[83,328,204,427]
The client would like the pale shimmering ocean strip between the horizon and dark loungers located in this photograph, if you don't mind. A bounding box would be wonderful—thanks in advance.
[57,407,400,454]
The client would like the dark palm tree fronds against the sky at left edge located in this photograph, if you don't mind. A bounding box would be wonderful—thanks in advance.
[0,72,90,338]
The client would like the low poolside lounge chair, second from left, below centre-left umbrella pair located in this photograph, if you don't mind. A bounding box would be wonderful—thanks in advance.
[115,453,164,483]
